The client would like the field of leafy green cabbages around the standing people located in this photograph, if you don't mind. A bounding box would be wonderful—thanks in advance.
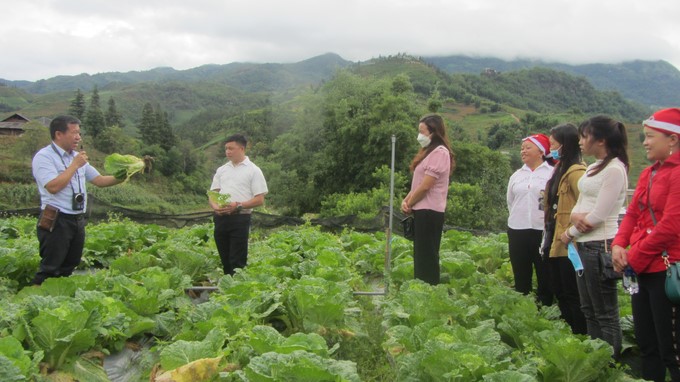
[0,218,631,382]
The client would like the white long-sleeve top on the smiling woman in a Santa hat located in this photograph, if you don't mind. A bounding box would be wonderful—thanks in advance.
[507,162,553,230]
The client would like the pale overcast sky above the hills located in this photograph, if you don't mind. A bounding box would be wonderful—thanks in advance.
[0,0,680,81]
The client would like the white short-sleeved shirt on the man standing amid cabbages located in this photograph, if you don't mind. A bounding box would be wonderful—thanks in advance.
[210,157,269,210]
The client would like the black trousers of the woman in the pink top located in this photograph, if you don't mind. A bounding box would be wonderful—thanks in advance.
[413,210,444,285]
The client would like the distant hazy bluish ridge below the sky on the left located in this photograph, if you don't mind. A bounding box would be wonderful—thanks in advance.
[0,53,351,94]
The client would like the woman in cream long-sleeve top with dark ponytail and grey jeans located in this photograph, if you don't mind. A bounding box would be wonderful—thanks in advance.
[560,116,629,359]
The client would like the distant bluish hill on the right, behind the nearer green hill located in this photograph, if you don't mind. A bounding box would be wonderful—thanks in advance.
[424,56,680,108]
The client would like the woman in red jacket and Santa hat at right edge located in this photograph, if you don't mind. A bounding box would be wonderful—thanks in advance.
[612,108,680,381]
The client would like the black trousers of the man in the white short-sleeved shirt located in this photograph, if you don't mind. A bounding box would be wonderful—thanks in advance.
[213,214,250,275]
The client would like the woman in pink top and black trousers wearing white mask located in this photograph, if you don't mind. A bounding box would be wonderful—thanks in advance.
[401,114,455,285]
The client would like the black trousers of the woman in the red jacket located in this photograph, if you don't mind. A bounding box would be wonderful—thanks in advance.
[631,271,680,381]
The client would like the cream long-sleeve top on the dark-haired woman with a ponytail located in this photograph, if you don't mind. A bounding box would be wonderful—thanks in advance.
[569,158,628,242]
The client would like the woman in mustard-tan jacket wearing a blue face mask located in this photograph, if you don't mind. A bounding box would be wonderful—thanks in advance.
[542,123,587,334]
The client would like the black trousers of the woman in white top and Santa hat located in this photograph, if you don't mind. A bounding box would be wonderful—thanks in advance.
[508,228,553,305]
